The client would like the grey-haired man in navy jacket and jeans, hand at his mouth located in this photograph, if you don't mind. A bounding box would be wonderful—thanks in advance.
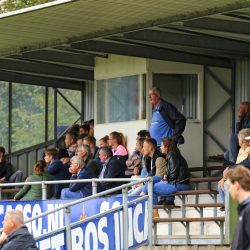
[61,156,100,199]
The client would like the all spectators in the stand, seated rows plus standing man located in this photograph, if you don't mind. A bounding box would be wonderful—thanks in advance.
[0,88,250,223]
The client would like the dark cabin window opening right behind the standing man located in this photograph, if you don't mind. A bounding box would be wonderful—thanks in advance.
[153,74,198,119]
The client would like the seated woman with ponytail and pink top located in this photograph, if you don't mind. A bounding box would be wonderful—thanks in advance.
[109,131,128,169]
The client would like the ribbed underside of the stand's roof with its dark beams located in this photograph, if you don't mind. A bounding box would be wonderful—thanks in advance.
[0,0,250,89]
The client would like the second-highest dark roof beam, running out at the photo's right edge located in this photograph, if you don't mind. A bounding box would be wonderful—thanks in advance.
[124,30,250,54]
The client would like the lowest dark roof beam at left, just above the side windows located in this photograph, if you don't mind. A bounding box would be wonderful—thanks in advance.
[0,70,80,90]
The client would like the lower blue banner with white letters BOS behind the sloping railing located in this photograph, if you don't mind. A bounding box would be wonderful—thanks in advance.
[36,199,148,250]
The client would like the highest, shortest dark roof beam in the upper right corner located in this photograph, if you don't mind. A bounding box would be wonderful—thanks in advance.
[183,17,250,35]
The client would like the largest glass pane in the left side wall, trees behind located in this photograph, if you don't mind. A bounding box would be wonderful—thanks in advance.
[11,83,45,152]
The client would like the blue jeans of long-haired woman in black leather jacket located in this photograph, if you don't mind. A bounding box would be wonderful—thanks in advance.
[142,176,189,205]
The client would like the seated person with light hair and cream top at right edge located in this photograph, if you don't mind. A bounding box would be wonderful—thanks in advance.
[218,128,250,211]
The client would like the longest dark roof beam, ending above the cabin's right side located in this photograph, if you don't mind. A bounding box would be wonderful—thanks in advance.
[71,41,231,68]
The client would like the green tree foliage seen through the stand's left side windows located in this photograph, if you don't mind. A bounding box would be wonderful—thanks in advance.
[0,81,81,152]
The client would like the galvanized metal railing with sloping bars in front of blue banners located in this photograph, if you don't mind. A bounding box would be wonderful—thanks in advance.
[0,177,153,250]
